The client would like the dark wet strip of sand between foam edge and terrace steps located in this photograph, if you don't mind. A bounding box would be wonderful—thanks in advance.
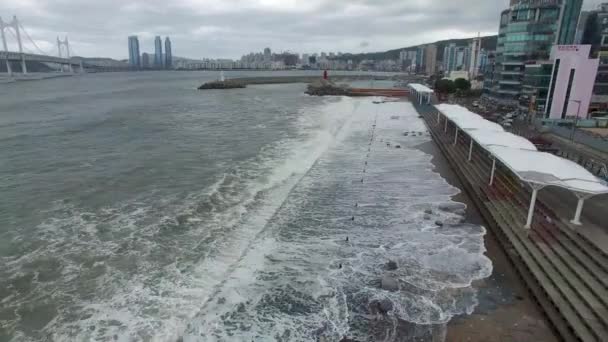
[418,141,559,342]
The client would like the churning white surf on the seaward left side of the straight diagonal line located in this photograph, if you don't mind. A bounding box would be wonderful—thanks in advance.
[0,98,352,341]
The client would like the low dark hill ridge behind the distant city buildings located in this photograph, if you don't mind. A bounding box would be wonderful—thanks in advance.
[339,35,498,62]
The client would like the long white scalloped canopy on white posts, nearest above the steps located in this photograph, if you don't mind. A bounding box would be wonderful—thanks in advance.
[436,104,608,228]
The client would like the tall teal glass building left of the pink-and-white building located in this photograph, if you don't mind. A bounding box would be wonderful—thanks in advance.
[485,0,581,104]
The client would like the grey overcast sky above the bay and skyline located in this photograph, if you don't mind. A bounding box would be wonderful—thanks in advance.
[0,0,602,59]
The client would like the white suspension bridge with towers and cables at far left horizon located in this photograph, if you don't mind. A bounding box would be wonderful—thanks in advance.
[0,16,124,77]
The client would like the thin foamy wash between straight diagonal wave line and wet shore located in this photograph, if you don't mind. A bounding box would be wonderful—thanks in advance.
[185,100,492,341]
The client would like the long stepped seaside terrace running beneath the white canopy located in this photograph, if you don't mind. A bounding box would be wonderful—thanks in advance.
[414,84,608,341]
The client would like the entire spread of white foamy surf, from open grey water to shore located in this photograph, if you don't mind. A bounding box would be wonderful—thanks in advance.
[2,98,491,341]
